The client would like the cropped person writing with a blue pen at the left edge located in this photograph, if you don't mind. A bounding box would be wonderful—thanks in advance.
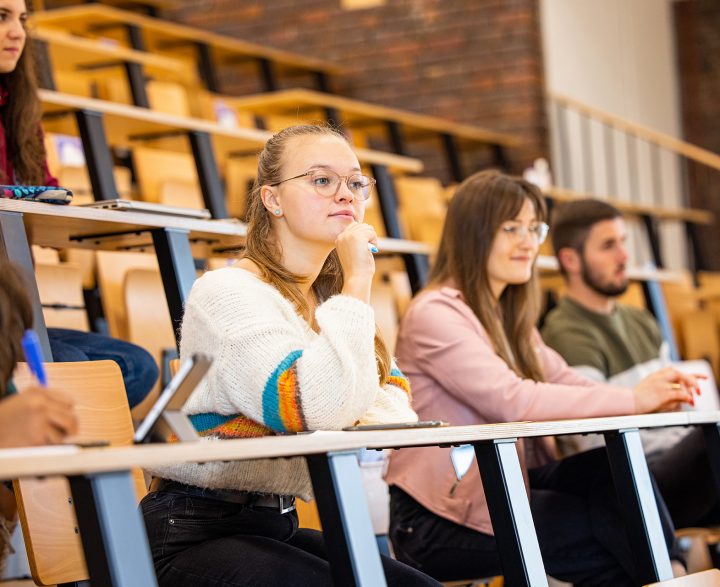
[0,260,77,571]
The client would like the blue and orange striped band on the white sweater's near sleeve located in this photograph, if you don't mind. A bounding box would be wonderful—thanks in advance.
[262,350,306,432]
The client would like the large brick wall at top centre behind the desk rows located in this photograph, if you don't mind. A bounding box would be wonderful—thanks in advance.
[163,0,548,179]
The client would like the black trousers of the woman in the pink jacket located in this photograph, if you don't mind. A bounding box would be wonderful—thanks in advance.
[390,448,679,587]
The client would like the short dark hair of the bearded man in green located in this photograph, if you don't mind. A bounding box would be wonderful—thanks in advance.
[550,198,622,258]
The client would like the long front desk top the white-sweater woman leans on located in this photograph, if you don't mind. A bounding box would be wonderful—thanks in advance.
[0,412,708,479]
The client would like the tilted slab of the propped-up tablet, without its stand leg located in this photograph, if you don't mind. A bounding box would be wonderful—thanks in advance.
[133,353,212,443]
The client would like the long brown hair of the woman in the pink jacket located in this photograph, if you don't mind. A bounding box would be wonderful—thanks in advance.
[430,171,547,381]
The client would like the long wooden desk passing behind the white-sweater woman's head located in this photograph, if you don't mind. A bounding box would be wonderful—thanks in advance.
[38,90,423,173]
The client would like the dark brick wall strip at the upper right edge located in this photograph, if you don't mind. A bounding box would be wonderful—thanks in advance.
[675,0,720,271]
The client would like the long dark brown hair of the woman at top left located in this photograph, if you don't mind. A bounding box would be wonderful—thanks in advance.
[0,26,46,185]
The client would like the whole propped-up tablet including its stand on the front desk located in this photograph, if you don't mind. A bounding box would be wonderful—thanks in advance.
[133,353,212,444]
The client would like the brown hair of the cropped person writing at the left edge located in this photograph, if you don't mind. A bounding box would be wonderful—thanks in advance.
[0,260,33,396]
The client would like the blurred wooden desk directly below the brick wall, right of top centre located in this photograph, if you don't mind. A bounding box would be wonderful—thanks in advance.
[223,89,520,147]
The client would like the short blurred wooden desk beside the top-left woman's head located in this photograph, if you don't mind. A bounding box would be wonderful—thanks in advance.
[31,27,197,83]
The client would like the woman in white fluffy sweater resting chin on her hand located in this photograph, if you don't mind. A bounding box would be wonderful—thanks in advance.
[142,126,437,587]
